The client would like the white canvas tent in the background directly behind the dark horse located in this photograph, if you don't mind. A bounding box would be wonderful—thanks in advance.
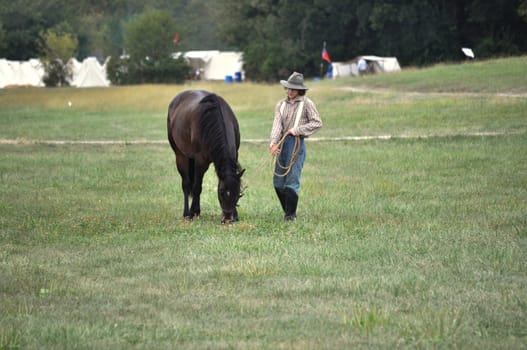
[174,50,243,80]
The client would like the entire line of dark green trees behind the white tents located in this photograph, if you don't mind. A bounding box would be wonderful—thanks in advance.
[0,0,527,83]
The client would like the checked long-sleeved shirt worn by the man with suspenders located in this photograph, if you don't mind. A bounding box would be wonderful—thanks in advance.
[271,96,322,145]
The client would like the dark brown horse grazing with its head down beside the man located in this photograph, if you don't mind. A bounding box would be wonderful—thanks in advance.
[167,90,244,223]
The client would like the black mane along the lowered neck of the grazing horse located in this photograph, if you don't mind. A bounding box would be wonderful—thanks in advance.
[199,93,240,174]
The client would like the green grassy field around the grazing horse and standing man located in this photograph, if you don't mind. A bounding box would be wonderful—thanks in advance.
[0,57,527,349]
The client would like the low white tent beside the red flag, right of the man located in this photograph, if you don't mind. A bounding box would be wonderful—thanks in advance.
[333,55,401,79]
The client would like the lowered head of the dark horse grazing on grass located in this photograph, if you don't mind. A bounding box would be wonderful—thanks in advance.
[218,169,245,224]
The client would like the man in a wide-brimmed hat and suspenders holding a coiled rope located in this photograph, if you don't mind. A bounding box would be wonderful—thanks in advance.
[269,72,322,221]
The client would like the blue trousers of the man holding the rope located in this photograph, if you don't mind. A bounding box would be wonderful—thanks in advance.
[273,135,306,194]
